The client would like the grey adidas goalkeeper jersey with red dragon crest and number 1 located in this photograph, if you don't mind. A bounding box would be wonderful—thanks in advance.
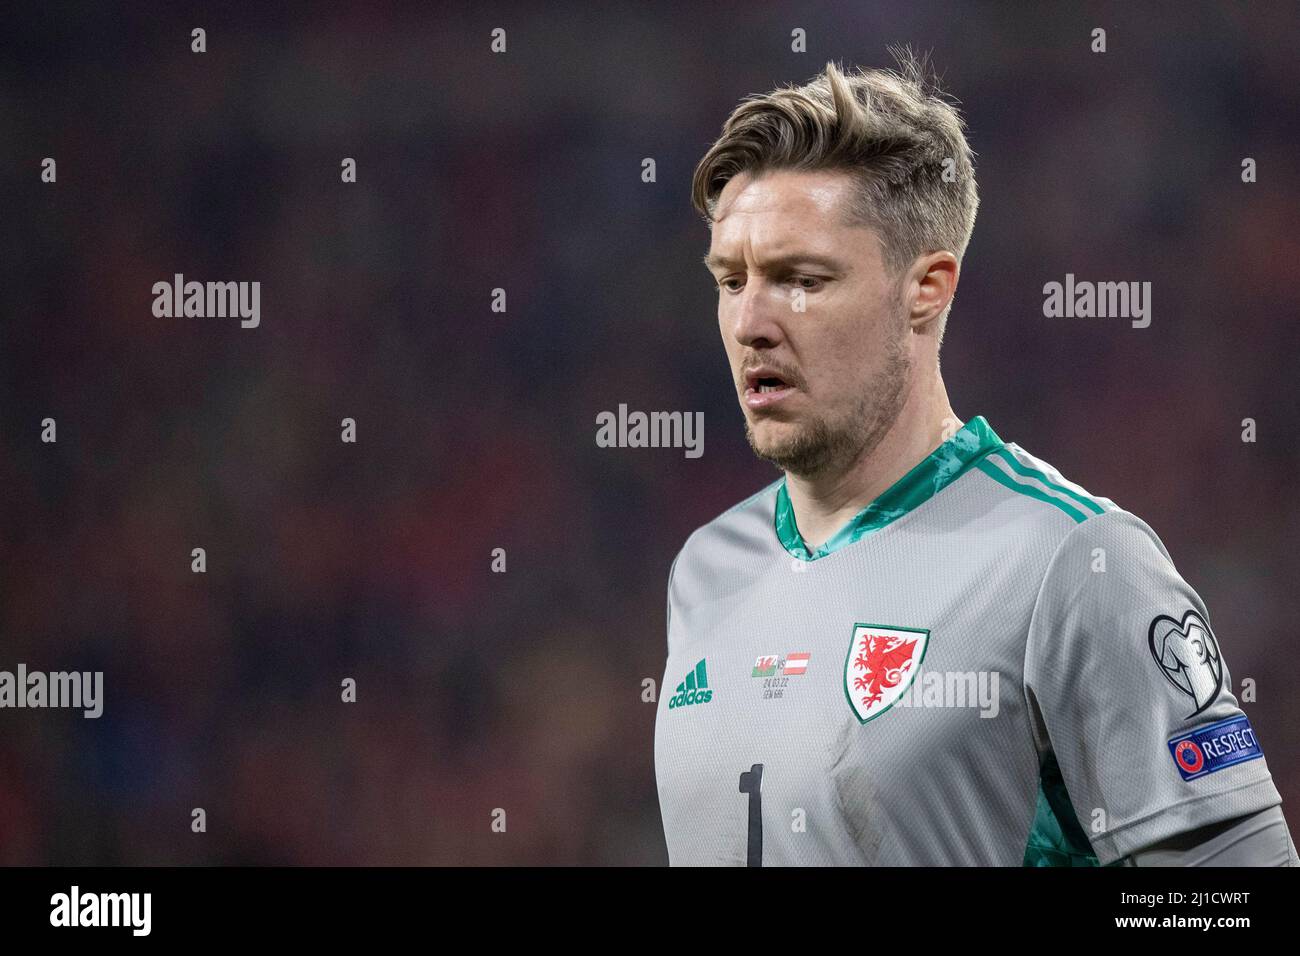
[655,418,1282,866]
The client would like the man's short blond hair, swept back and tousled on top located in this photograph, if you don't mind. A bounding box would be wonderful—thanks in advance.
[692,48,979,338]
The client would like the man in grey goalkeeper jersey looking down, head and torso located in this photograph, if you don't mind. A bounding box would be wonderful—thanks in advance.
[655,56,1300,866]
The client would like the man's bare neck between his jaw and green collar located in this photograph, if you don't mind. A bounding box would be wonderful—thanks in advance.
[785,397,962,550]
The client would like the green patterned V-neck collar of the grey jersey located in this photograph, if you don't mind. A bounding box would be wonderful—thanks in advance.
[776,415,1004,561]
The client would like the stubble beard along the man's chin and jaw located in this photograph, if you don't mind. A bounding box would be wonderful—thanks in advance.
[745,326,911,479]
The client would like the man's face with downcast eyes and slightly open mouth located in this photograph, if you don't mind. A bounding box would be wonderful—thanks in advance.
[706,170,913,477]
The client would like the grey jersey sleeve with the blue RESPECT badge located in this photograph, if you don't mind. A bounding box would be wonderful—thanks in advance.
[1024,509,1282,865]
